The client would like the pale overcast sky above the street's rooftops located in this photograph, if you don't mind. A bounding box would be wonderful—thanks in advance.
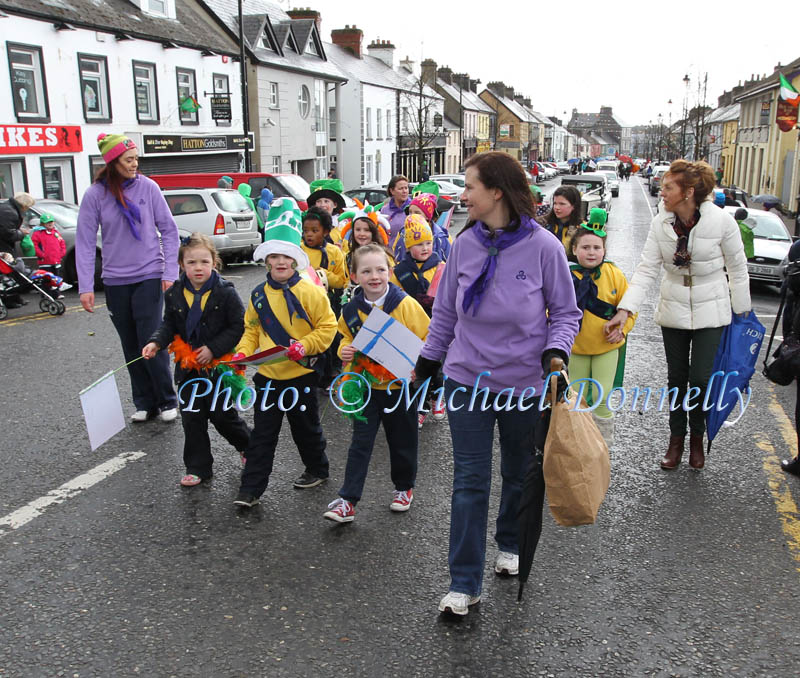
[298,0,800,125]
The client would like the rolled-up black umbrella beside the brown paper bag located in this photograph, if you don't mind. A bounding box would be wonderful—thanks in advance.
[517,358,566,601]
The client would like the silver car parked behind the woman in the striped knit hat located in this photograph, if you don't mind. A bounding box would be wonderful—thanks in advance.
[163,188,261,261]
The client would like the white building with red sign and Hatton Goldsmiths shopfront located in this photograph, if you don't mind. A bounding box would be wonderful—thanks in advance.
[0,0,246,203]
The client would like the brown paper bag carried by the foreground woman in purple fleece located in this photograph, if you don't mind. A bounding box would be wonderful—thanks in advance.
[542,377,611,527]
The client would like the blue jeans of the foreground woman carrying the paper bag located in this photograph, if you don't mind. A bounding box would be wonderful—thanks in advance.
[445,379,541,596]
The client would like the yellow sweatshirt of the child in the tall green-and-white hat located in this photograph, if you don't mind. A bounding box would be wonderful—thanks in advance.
[236,278,336,379]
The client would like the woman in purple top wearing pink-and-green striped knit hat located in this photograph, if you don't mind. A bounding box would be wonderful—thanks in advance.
[75,134,179,423]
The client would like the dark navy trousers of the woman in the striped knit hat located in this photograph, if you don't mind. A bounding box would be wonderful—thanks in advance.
[106,278,178,413]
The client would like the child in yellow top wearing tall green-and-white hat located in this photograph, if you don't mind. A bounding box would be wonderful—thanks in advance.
[233,198,336,507]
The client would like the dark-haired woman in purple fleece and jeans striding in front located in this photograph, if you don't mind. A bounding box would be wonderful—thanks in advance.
[415,152,581,615]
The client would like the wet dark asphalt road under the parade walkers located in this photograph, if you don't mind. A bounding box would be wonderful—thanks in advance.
[0,178,800,678]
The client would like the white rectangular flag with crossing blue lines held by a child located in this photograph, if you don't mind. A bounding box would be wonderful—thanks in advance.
[353,308,425,379]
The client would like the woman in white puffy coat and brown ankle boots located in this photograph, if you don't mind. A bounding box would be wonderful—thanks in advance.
[607,160,750,470]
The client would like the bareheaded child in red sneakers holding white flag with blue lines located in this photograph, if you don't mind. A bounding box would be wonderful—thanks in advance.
[324,244,430,523]
